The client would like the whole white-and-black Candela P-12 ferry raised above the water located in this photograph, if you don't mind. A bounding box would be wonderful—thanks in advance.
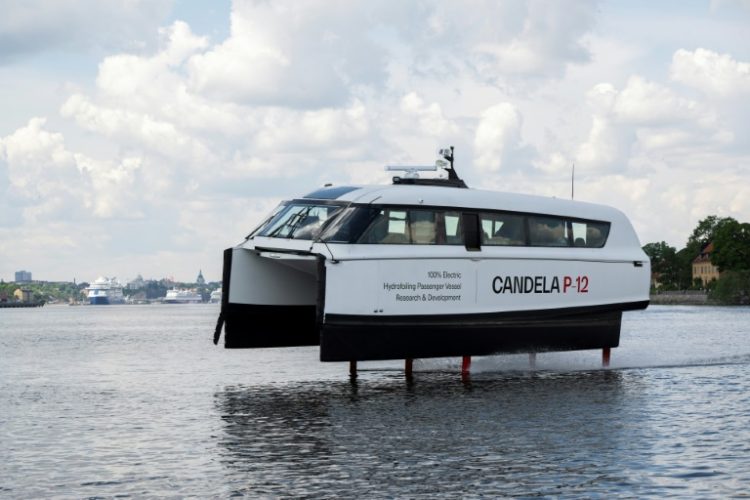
[214,148,650,368]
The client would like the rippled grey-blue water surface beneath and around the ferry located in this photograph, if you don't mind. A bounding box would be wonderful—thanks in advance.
[0,305,750,498]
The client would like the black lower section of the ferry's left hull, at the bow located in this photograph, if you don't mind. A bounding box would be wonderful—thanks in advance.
[224,302,320,349]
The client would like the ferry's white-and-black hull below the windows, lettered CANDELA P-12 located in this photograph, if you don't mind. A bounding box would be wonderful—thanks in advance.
[217,244,650,361]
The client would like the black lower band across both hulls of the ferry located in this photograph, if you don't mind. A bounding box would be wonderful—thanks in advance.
[224,303,645,361]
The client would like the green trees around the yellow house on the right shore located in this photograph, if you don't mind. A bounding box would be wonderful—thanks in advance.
[643,215,750,304]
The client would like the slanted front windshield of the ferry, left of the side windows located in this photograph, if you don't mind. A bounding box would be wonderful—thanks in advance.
[255,202,343,240]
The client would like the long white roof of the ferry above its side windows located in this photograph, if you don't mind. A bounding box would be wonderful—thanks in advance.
[303,184,624,221]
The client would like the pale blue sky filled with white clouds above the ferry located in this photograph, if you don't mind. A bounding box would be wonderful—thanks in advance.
[0,0,750,282]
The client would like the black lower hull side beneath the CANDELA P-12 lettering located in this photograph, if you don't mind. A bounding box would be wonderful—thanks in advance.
[320,302,648,361]
